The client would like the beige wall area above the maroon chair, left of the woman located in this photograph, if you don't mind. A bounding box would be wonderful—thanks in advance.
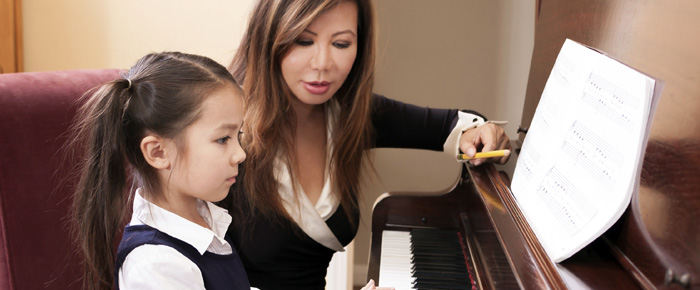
[22,0,253,71]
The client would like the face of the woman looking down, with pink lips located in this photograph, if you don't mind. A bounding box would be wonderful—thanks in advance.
[281,1,357,109]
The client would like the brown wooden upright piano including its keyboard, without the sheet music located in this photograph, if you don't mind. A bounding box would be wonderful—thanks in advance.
[368,0,700,289]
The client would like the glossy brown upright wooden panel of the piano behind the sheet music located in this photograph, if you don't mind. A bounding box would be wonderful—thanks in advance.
[519,0,700,288]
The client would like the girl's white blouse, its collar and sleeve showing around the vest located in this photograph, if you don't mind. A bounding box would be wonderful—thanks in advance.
[118,189,233,290]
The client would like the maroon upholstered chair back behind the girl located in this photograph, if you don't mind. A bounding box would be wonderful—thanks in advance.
[0,69,119,290]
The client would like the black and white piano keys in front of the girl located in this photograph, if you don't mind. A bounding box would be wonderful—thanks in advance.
[379,229,477,290]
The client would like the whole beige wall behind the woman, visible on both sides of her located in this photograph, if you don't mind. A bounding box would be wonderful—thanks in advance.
[22,0,535,285]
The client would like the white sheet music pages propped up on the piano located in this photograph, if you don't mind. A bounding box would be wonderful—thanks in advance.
[511,39,661,262]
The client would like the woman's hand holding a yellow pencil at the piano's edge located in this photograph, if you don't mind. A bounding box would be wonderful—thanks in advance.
[459,123,511,165]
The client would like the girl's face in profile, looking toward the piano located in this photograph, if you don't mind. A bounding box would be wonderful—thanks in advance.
[164,85,246,202]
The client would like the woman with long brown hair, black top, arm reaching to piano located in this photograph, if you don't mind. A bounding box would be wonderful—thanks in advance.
[223,0,509,289]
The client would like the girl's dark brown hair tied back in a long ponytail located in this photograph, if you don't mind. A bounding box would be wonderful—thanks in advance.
[66,52,238,290]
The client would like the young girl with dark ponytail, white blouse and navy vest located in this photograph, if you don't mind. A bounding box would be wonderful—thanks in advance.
[71,52,250,289]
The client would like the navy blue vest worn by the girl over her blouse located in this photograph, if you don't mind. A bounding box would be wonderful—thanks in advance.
[115,225,250,290]
